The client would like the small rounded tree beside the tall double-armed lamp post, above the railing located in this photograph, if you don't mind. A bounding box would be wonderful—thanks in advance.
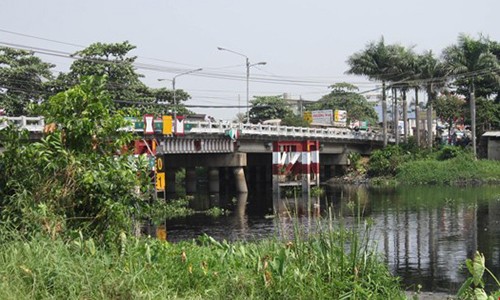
[249,96,293,123]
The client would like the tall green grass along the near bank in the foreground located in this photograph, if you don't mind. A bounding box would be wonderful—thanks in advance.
[0,210,404,299]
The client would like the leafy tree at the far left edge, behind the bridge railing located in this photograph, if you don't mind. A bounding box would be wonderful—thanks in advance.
[0,47,54,116]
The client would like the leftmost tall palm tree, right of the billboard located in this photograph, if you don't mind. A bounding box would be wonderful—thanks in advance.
[346,37,394,147]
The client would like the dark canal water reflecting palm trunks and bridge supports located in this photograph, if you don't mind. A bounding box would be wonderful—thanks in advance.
[167,185,500,293]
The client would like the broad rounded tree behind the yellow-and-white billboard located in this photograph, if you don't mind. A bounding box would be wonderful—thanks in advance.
[307,82,377,124]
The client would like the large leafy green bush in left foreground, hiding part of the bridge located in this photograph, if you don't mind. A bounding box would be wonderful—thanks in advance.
[0,77,151,240]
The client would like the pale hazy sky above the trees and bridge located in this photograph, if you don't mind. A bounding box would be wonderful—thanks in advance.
[0,0,500,120]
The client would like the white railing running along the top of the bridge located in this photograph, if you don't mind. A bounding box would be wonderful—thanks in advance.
[0,116,394,141]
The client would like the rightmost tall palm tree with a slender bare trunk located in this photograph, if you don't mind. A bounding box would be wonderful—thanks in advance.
[443,34,498,157]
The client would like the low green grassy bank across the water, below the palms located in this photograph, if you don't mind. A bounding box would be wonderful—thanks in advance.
[326,148,500,186]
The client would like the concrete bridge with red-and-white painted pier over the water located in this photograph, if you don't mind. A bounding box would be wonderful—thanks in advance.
[0,115,394,210]
